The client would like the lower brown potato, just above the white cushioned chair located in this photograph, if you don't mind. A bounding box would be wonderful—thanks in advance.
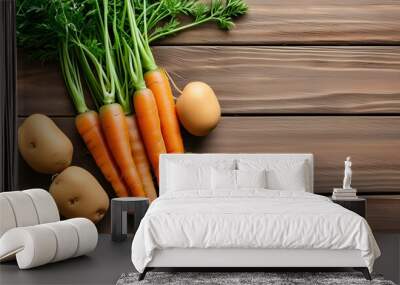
[49,166,109,223]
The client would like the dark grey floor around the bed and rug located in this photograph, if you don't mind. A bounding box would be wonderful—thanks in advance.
[0,233,400,285]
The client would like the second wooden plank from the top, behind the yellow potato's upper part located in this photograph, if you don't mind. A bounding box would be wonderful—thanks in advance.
[18,47,400,116]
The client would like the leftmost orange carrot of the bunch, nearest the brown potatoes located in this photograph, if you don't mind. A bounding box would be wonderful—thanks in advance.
[75,111,128,197]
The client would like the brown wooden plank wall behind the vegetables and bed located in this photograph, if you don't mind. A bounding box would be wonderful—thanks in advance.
[18,0,400,231]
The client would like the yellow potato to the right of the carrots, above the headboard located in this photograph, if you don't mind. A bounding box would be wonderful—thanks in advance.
[176,82,221,136]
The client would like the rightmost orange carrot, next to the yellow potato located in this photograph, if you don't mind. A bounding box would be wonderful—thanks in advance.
[144,68,185,153]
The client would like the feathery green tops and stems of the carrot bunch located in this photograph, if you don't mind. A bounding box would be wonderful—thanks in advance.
[16,0,247,113]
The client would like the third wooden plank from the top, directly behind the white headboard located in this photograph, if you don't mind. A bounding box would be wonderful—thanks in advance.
[19,116,400,193]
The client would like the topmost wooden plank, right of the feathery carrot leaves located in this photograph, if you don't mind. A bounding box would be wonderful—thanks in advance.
[157,0,400,45]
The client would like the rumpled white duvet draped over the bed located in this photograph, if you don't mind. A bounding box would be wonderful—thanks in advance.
[132,189,380,272]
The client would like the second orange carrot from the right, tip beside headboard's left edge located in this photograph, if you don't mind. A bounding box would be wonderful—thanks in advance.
[133,88,166,179]
